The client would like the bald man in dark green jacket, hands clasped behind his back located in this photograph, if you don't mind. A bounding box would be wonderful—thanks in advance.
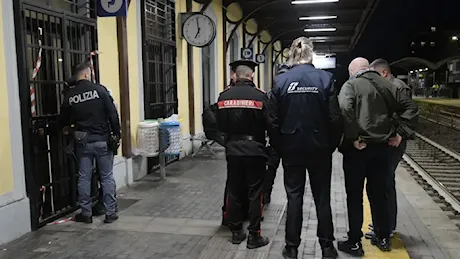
[338,58,401,257]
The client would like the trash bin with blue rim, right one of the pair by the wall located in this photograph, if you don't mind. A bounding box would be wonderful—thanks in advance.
[160,121,182,156]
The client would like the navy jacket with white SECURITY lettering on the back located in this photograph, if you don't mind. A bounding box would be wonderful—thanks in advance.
[270,64,342,156]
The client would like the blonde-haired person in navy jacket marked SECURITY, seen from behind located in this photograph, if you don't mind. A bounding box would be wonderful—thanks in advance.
[270,37,342,259]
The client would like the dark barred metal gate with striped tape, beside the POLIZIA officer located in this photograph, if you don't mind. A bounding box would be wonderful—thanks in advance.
[17,0,97,229]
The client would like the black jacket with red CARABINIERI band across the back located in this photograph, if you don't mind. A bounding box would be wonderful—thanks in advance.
[217,79,276,157]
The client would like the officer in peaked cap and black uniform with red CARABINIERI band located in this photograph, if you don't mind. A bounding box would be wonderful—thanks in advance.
[217,60,276,249]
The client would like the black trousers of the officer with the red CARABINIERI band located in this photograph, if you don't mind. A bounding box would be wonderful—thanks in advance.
[227,156,267,235]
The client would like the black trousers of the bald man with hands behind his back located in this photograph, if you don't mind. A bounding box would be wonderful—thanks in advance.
[343,143,391,243]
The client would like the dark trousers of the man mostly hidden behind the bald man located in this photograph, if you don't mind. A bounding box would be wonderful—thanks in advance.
[366,140,407,231]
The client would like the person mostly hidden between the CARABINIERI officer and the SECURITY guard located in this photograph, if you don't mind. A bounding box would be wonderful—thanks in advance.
[263,63,290,205]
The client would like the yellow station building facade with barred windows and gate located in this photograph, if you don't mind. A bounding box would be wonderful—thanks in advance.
[0,0,286,244]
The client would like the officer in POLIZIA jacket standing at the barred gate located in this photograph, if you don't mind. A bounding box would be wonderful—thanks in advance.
[59,63,121,224]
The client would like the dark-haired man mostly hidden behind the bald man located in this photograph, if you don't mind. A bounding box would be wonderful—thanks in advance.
[366,59,418,239]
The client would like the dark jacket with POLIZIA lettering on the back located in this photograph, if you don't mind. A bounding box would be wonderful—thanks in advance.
[59,80,120,142]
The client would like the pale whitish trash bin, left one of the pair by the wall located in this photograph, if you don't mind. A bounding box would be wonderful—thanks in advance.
[138,120,160,157]
